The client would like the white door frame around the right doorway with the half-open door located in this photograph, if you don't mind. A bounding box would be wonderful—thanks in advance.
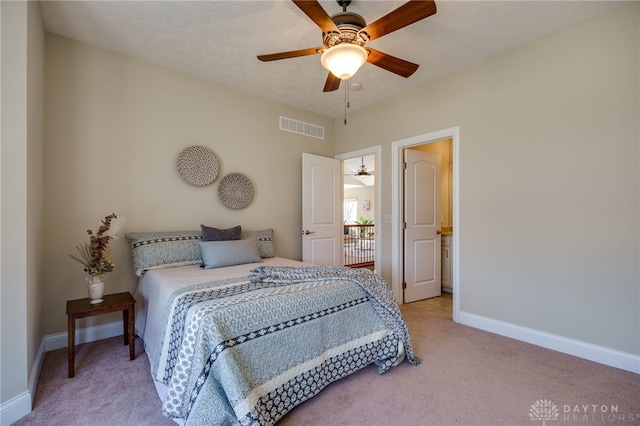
[390,126,461,322]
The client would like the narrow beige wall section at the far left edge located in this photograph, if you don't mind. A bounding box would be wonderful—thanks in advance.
[0,2,27,401]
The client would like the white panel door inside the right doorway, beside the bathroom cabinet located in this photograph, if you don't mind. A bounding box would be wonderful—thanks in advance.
[403,149,441,303]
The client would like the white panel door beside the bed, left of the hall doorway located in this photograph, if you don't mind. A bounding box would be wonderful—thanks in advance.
[302,153,342,266]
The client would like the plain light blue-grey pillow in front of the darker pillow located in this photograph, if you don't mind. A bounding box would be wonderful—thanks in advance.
[199,240,262,269]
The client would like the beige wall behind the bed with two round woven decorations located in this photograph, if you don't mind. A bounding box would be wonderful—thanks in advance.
[44,34,334,334]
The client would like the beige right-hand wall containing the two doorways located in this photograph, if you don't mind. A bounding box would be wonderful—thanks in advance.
[335,4,640,354]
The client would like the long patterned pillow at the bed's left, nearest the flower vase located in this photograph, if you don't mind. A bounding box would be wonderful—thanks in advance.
[125,231,202,277]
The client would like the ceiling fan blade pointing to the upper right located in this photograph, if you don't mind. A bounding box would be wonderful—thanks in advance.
[360,0,436,40]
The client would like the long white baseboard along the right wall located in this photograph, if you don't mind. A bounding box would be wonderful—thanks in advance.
[458,311,640,374]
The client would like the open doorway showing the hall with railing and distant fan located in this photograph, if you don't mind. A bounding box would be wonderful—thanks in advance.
[336,145,381,271]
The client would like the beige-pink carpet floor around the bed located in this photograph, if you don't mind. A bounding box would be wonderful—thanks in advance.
[15,296,640,426]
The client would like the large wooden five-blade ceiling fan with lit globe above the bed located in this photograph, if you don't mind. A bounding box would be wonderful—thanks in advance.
[258,0,436,92]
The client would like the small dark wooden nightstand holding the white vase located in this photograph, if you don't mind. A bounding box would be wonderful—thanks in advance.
[67,292,136,377]
